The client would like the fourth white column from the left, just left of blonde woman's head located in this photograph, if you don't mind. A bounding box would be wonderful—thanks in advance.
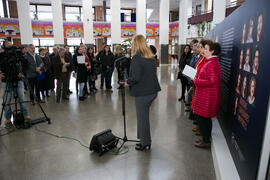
[111,0,121,45]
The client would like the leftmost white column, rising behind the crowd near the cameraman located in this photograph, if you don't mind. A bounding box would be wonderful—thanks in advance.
[17,0,33,45]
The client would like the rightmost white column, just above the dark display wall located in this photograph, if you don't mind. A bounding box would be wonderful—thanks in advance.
[212,0,226,29]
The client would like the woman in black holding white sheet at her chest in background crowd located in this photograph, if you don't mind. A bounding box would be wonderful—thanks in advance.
[73,47,90,101]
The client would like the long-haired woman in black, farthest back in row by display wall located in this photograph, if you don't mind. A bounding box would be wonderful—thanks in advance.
[178,45,191,101]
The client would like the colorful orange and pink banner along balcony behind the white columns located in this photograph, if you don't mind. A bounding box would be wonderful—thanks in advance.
[0,18,178,38]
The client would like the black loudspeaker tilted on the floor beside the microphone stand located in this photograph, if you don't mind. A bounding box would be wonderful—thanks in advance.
[89,129,119,156]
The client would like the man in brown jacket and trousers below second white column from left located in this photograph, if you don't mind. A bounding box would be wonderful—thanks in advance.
[53,48,70,103]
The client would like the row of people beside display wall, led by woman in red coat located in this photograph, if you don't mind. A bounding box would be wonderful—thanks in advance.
[178,39,221,148]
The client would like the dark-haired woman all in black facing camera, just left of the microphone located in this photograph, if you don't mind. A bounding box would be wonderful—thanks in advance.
[99,45,114,92]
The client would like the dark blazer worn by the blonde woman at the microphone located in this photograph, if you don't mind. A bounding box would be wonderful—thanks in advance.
[127,54,161,96]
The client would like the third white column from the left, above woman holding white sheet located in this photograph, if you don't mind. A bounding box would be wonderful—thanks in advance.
[82,0,94,46]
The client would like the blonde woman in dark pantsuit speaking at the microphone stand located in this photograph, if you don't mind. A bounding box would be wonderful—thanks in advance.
[125,35,161,151]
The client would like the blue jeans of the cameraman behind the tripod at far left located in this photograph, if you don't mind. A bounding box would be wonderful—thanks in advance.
[2,81,28,119]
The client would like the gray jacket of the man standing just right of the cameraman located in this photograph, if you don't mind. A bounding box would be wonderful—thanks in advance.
[25,52,43,78]
